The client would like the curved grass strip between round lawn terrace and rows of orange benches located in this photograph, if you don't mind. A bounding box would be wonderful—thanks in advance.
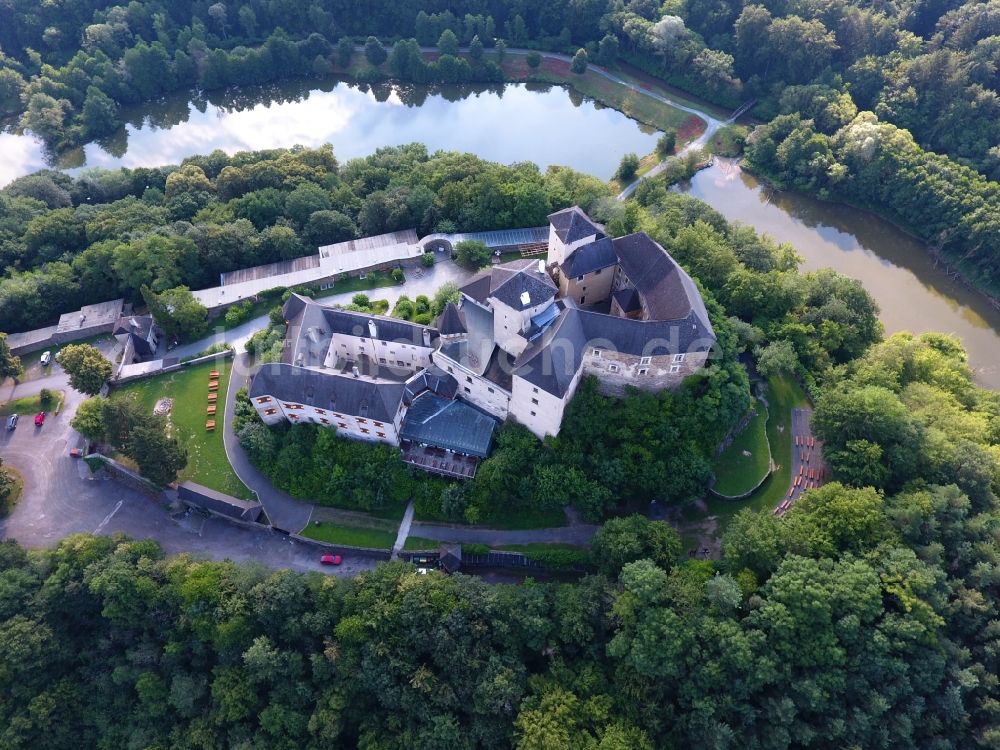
[685,378,809,533]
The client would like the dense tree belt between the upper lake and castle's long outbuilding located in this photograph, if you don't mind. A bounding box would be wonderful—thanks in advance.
[0,144,610,332]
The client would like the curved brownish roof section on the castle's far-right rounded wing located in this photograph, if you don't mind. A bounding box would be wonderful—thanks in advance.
[614,232,712,333]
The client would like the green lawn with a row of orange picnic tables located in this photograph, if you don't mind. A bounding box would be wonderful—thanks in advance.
[112,359,253,499]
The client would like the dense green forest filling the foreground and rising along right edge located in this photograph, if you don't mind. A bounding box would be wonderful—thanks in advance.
[0,326,1000,750]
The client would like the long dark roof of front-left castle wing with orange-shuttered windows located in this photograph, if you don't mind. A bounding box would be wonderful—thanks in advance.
[250,364,406,422]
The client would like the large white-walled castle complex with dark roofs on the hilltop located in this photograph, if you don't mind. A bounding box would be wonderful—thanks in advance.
[250,206,715,476]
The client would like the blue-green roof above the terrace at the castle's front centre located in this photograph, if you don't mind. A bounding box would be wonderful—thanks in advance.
[399,393,497,458]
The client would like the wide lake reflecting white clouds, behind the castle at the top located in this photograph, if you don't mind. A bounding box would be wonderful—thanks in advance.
[0,81,656,185]
